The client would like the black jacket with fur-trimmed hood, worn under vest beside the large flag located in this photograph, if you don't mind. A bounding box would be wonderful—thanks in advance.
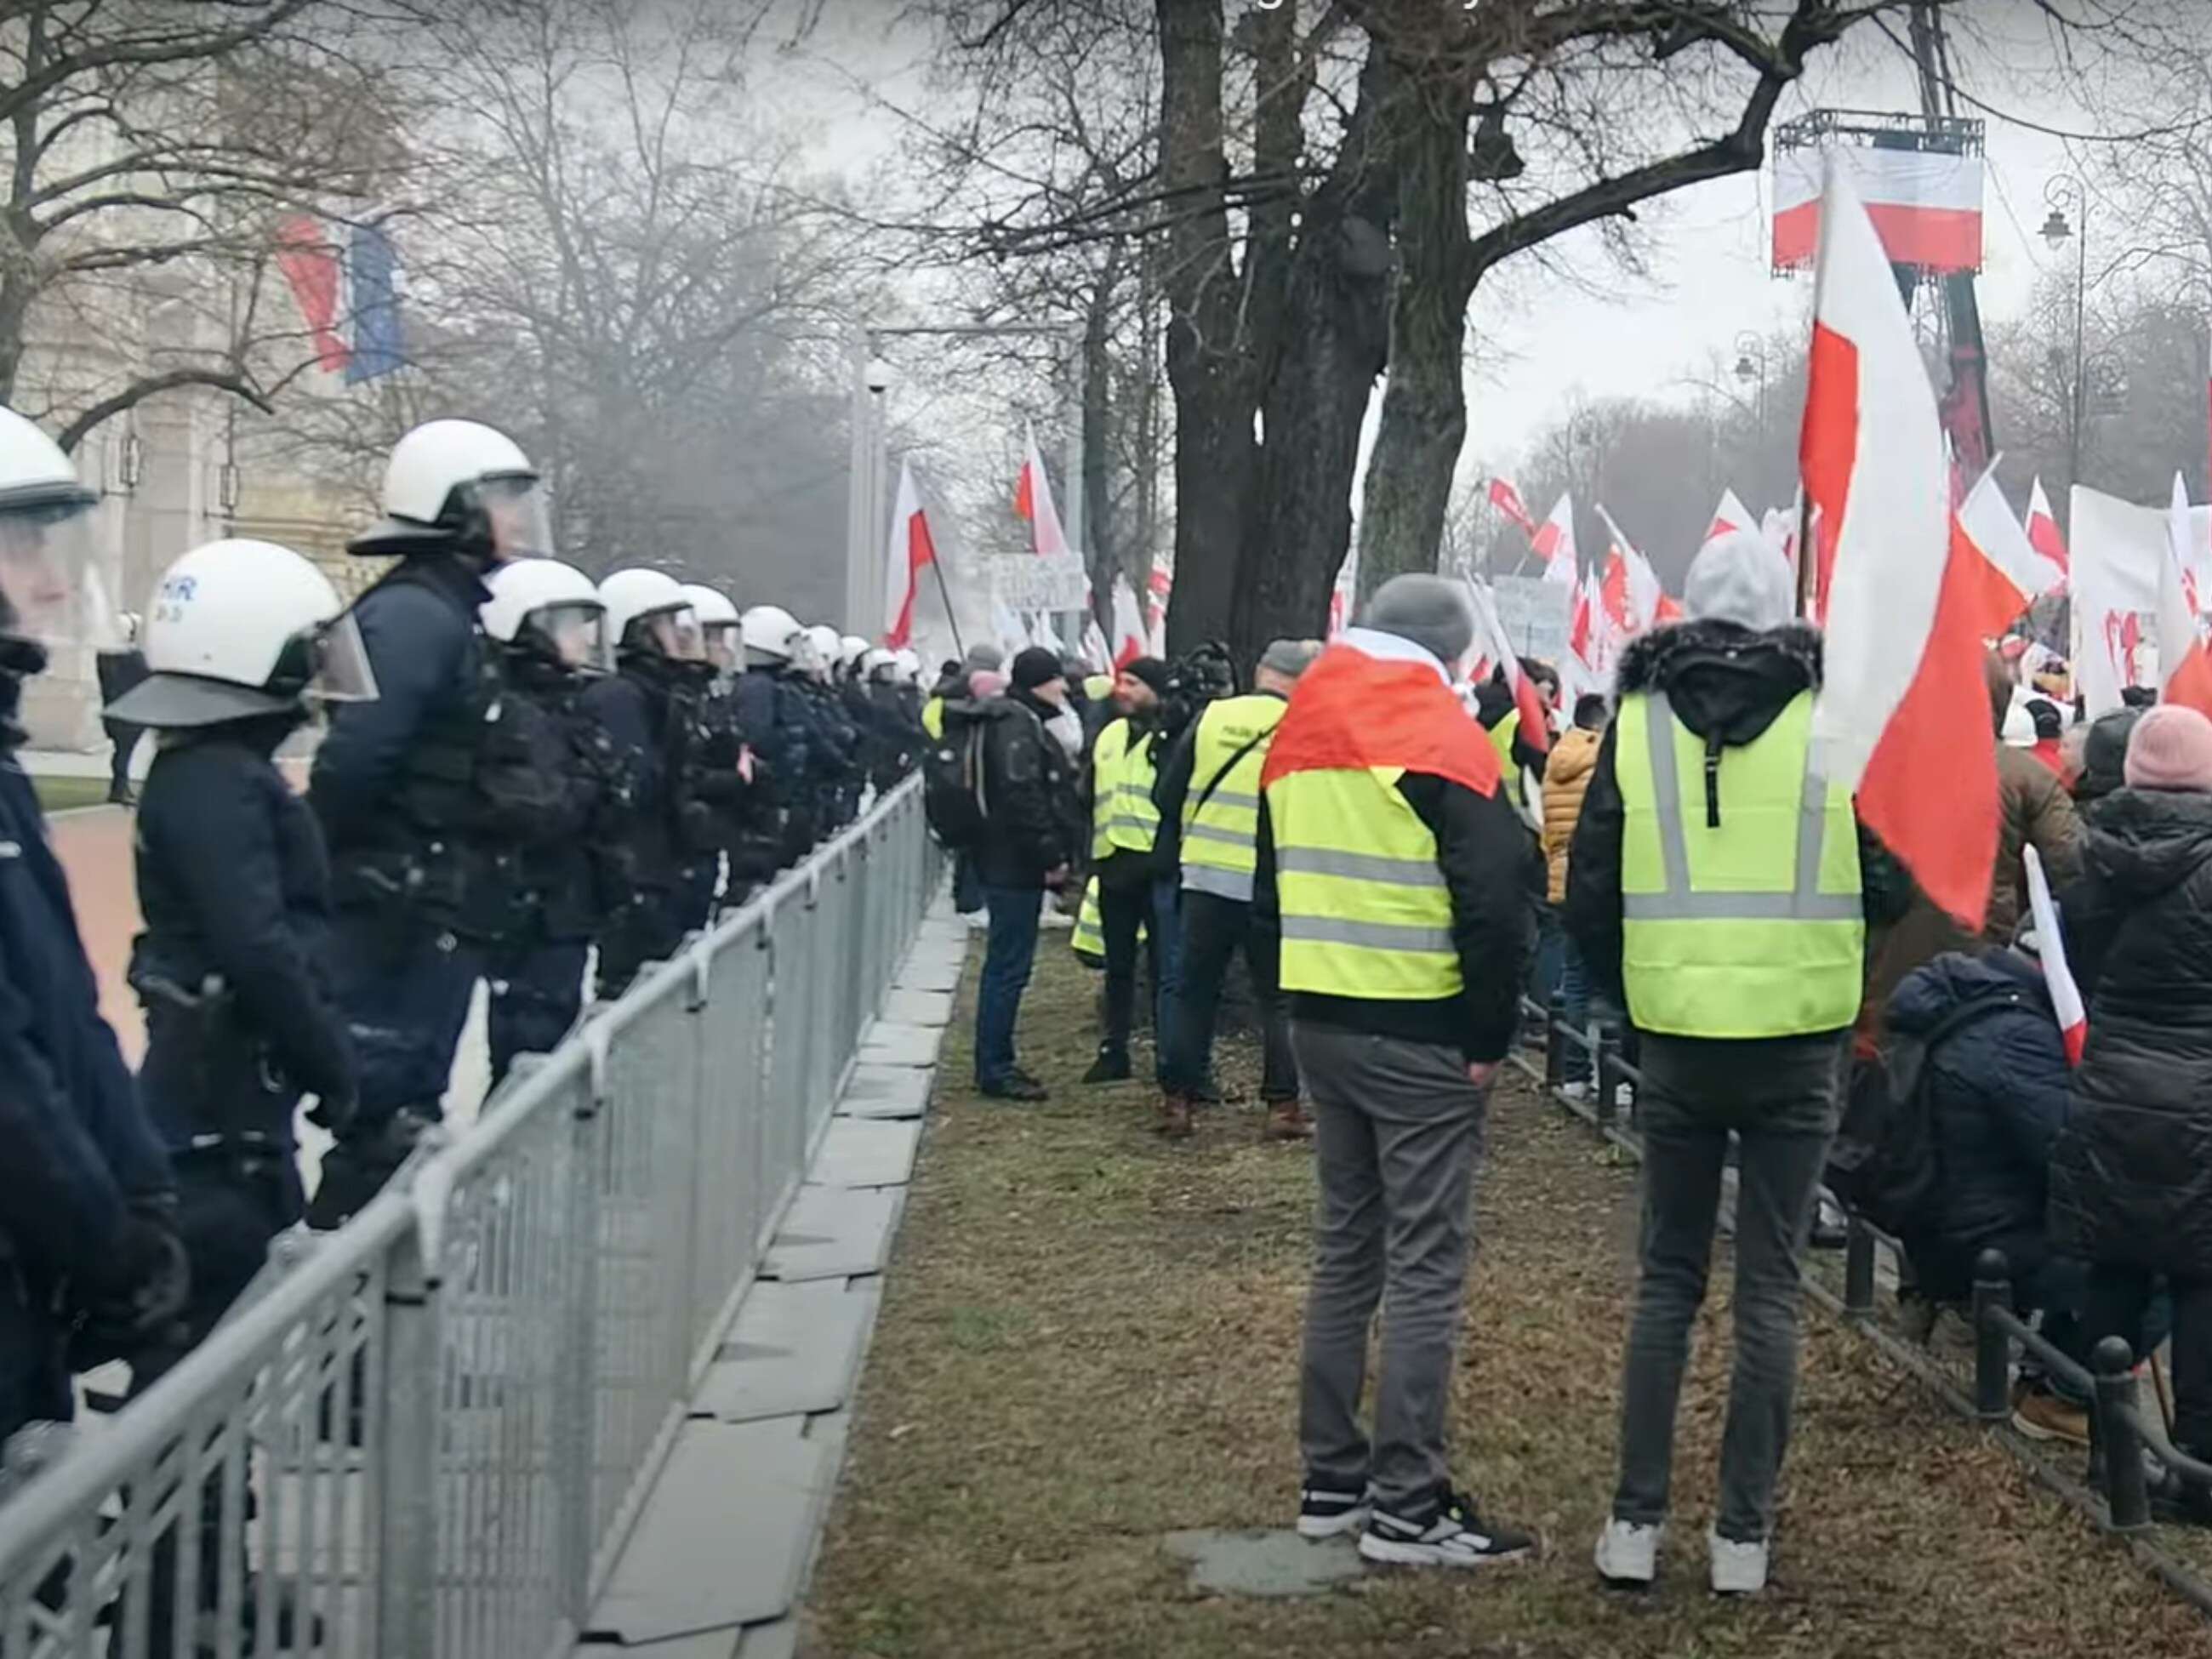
[1564,622,1911,1022]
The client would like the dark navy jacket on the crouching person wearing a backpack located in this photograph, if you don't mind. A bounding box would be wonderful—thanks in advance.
[1887,949,2068,1297]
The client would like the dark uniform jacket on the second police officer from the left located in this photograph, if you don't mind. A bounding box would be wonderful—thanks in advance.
[130,716,356,1148]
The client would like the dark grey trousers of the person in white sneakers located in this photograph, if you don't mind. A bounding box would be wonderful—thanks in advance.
[1612,1035,1844,1544]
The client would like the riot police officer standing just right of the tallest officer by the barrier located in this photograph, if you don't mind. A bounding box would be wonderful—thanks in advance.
[480,560,630,1088]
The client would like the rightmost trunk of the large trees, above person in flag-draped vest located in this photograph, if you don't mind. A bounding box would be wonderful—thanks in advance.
[1360,64,1475,600]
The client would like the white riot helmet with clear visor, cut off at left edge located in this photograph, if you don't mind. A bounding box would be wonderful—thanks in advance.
[0,409,117,675]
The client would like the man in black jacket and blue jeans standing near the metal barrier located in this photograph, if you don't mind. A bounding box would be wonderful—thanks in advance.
[964,646,1075,1102]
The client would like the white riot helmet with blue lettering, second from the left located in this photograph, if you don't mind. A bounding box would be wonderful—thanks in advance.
[106,538,376,727]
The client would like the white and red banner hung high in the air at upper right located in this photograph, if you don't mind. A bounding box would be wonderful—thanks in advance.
[1774,144,1982,272]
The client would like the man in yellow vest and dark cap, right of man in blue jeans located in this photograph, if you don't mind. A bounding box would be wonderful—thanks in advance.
[1084,657,1177,1084]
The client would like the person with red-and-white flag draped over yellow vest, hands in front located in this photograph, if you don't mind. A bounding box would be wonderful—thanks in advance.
[1254,575,1533,1566]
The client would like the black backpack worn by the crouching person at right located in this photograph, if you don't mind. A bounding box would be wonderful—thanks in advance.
[1827,989,2027,1241]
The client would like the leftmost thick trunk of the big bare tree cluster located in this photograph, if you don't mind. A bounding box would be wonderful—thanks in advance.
[1157,0,1254,653]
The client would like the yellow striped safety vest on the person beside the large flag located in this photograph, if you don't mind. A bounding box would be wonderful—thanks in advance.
[1612,693,1867,1040]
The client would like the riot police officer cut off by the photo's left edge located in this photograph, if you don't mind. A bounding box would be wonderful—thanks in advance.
[0,409,185,1440]
